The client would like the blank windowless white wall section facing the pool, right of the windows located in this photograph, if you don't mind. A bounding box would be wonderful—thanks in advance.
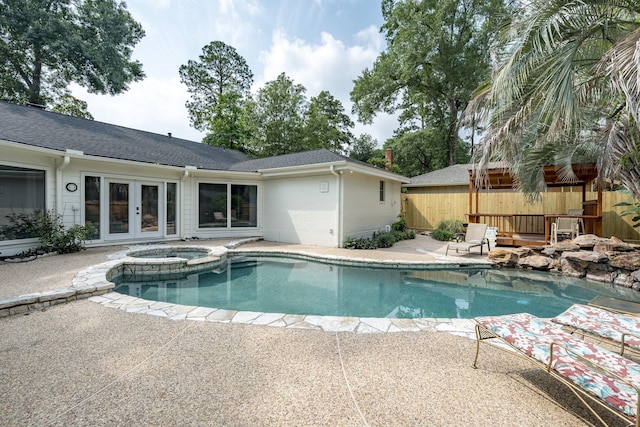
[262,174,340,247]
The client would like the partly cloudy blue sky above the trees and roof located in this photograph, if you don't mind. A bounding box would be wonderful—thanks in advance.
[72,0,397,146]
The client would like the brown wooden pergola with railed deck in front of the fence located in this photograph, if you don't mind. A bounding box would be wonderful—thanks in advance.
[468,163,602,246]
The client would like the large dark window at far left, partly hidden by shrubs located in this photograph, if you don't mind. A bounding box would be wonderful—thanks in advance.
[0,165,45,240]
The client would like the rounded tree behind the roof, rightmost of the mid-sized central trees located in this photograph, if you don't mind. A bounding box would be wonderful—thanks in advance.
[304,90,354,154]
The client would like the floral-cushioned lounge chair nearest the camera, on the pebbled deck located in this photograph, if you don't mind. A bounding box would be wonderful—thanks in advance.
[473,313,640,427]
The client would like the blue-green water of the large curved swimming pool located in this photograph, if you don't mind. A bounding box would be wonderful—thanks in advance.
[115,257,640,318]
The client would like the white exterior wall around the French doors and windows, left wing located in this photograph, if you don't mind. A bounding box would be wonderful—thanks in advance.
[0,146,263,256]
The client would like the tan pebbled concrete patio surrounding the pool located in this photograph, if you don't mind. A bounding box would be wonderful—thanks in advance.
[0,236,624,426]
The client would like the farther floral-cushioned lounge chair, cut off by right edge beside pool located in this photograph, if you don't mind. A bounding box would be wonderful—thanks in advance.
[551,304,640,354]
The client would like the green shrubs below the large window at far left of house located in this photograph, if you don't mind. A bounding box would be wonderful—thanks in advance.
[0,211,95,254]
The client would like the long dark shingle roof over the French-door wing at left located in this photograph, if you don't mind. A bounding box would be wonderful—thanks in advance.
[0,102,249,170]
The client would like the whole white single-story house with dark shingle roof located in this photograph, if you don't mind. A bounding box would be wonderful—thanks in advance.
[0,102,409,257]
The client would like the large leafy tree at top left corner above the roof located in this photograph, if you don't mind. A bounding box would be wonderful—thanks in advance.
[0,0,144,105]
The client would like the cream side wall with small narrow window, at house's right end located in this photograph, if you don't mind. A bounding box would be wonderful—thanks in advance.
[342,172,401,240]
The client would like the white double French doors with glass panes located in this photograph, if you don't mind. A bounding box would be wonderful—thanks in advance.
[107,180,164,239]
